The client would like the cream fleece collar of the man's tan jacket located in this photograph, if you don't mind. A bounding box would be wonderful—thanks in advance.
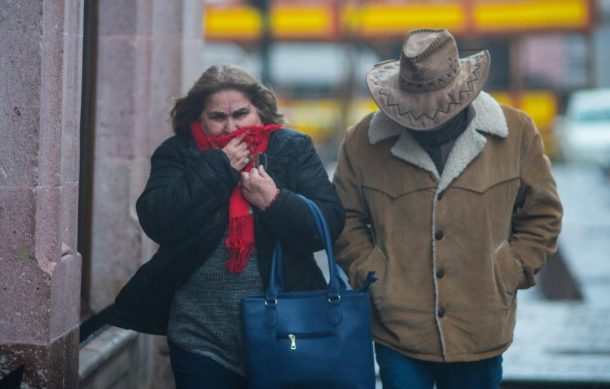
[368,92,508,192]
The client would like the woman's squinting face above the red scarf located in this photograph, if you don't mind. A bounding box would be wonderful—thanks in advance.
[201,89,263,136]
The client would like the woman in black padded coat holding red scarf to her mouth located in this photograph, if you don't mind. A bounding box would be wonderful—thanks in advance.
[106,65,344,388]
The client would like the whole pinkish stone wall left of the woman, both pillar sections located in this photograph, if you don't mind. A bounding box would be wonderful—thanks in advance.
[0,0,203,388]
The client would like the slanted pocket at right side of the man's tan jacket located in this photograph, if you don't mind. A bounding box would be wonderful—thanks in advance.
[493,240,523,306]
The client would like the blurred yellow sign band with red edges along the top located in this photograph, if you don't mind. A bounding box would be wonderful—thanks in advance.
[203,0,593,42]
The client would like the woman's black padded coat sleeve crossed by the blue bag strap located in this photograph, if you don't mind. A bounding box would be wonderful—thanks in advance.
[255,136,344,252]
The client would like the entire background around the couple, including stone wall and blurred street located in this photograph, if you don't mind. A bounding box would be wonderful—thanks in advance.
[0,0,610,389]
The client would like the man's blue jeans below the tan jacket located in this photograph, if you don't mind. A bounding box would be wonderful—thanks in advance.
[375,343,502,389]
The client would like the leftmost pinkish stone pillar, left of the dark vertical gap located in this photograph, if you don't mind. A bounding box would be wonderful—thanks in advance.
[0,0,82,388]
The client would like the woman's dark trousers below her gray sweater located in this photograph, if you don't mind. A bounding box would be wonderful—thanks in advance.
[169,343,246,389]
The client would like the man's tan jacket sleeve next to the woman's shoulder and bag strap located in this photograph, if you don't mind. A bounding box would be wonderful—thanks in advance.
[333,119,383,288]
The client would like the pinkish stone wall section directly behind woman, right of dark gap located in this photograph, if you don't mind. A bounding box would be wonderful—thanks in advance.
[81,0,203,388]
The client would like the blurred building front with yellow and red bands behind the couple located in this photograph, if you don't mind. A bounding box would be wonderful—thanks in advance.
[202,0,610,168]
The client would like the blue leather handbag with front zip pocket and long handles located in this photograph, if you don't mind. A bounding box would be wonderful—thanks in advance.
[241,196,375,389]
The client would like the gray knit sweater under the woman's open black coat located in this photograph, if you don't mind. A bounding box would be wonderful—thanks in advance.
[167,239,263,375]
